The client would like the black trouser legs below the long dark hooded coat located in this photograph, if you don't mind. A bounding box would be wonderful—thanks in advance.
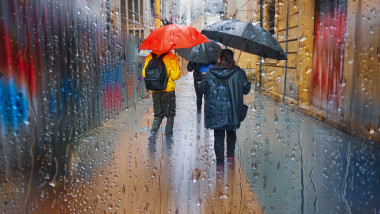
[214,129,236,163]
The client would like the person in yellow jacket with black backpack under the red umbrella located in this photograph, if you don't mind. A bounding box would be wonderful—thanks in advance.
[142,52,181,140]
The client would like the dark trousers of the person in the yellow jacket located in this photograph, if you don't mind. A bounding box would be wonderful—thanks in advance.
[151,91,176,135]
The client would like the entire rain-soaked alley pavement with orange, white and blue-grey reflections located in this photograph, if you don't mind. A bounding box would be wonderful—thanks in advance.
[0,75,380,214]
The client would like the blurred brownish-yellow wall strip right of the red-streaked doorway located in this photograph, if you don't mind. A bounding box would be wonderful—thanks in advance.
[342,0,380,141]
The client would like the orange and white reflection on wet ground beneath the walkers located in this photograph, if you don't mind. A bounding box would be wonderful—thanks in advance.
[20,75,261,213]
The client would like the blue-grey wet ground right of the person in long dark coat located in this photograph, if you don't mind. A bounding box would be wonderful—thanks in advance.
[239,90,380,213]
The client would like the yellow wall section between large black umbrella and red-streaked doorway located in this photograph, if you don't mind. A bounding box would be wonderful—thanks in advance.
[251,0,314,104]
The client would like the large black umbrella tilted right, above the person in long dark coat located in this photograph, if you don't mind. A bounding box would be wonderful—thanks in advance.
[201,20,286,60]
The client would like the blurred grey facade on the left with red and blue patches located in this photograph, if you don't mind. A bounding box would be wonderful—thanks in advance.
[0,0,178,192]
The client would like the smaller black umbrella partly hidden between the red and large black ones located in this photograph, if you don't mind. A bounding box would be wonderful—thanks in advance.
[176,40,222,64]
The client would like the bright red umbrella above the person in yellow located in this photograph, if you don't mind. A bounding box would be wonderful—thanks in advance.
[139,24,209,52]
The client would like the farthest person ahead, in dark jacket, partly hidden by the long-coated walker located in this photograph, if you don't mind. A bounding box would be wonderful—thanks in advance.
[187,61,215,112]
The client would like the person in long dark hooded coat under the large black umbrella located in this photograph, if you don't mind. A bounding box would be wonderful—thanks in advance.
[199,49,251,164]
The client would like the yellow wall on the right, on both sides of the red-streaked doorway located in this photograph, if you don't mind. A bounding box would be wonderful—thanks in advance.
[240,0,380,141]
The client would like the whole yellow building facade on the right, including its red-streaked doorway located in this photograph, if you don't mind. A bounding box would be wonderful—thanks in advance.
[225,0,380,140]
